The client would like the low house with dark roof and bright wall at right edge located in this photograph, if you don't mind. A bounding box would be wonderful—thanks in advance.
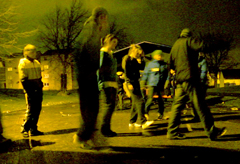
[209,69,240,88]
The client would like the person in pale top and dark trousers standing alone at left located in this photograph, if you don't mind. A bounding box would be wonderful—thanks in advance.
[18,44,43,137]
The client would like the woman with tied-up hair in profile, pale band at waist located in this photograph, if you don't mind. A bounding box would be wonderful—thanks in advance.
[98,34,118,137]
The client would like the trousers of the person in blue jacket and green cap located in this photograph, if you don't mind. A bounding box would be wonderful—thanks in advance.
[145,86,164,115]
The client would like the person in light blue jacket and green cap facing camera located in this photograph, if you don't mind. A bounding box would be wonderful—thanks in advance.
[141,50,168,119]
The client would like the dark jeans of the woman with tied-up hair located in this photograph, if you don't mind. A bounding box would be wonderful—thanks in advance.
[100,87,117,132]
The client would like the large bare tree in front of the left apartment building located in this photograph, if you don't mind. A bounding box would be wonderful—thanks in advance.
[38,0,88,92]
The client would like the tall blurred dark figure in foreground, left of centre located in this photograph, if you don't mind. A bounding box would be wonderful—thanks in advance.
[74,7,109,149]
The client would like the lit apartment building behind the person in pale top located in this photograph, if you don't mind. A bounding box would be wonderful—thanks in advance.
[0,51,78,90]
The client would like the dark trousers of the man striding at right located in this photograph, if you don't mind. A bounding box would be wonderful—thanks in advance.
[167,82,214,136]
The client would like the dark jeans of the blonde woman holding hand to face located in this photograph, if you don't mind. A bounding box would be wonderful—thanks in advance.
[130,85,147,124]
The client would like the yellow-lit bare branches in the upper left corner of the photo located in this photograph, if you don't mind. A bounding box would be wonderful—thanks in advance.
[0,0,37,54]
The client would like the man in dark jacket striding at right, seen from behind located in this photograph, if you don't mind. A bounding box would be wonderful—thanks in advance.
[167,29,226,140]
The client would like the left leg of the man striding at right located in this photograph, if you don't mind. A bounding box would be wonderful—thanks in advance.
[167,83,187,139]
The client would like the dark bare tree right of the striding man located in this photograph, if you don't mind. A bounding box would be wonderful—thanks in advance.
[201,32,236,87]
